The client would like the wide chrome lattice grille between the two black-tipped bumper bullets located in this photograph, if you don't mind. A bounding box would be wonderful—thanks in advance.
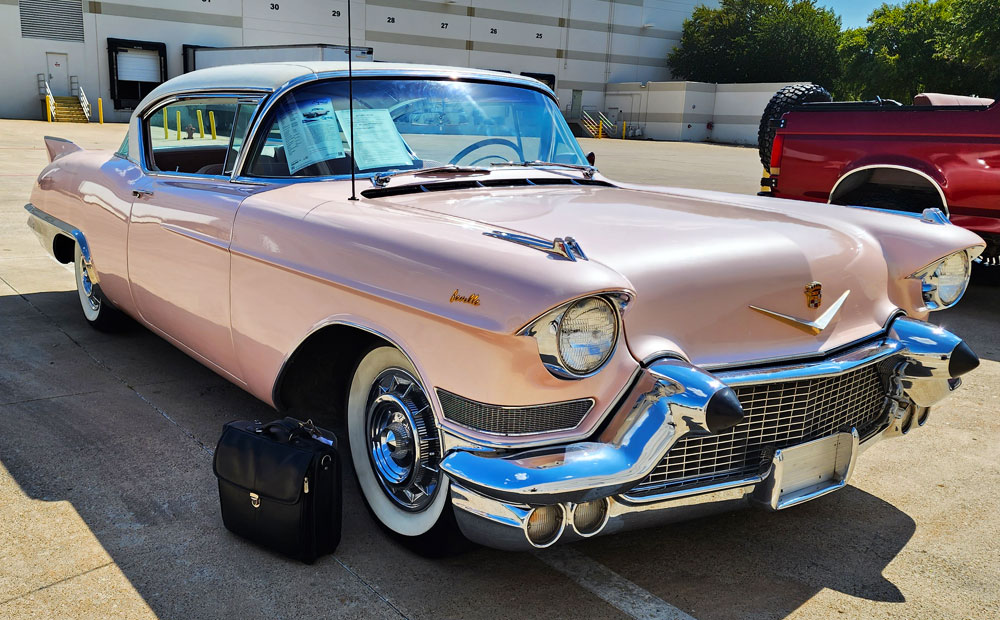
[629,364,886,497]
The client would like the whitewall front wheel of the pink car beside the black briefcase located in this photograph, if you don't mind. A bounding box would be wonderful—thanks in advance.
[347,346,455,554]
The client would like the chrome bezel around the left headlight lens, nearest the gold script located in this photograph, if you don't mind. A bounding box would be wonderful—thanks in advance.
[518,292,632,379]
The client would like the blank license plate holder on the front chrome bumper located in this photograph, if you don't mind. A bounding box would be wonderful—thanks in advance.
[750,428,860,510]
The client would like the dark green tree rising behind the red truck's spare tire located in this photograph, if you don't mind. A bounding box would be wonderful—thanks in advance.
[667,0,840,85]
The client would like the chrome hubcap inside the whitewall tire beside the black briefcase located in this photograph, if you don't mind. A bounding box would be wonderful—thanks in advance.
[365,368,441,512]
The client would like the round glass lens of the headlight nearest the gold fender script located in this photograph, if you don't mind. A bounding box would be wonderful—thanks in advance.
[557,297,618,375]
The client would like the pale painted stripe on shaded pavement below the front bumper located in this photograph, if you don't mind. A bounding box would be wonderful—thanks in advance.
[535,547,695,620]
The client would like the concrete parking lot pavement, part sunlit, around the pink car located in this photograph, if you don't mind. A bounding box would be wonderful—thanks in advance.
[0,121,1000,619]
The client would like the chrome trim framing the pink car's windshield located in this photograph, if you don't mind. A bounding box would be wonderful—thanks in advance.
[231,69,559,183]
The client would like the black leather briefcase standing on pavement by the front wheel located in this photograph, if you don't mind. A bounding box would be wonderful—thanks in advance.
[214,418,342,564]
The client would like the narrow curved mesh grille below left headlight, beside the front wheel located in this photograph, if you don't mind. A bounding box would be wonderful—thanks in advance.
[437,389,594,435]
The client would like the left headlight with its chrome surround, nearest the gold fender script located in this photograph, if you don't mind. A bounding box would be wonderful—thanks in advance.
[521,296,624,379]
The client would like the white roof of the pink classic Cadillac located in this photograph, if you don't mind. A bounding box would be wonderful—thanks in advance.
[136,61,549,112]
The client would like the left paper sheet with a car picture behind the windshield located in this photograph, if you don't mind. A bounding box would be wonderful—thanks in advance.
[278,99,344,174]
